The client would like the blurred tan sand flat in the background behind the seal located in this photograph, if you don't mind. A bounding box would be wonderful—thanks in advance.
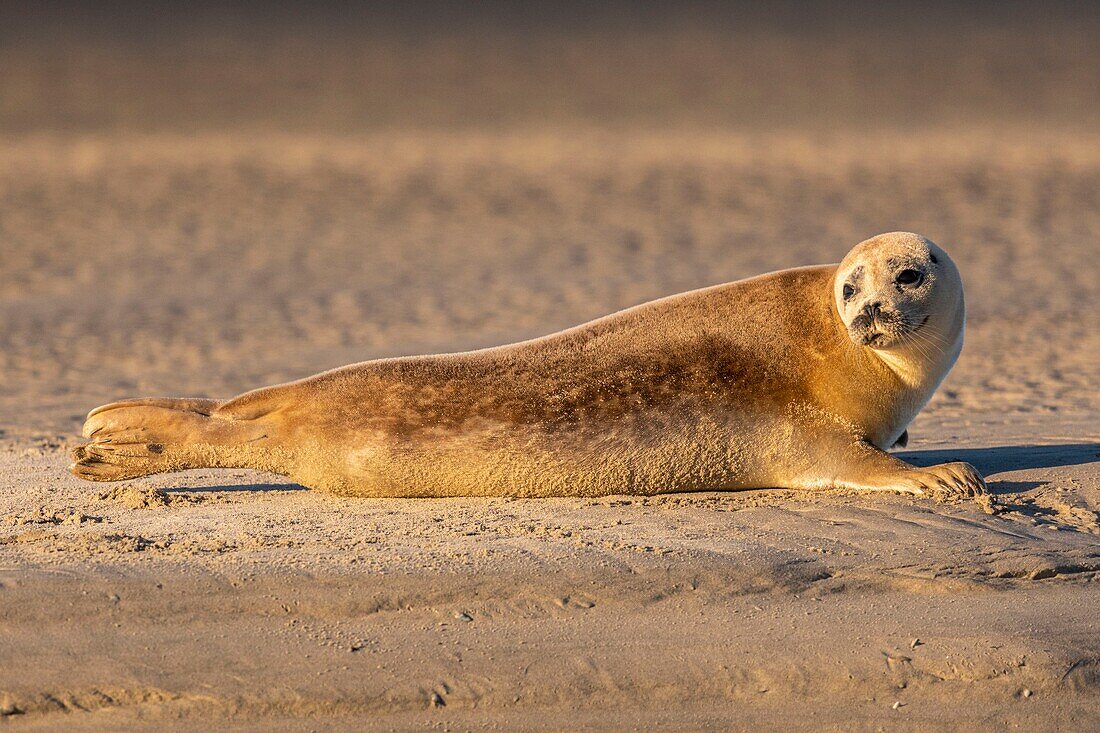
[0,2,1100,439]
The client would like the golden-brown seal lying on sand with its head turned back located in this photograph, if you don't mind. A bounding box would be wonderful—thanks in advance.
[72,232,985,497]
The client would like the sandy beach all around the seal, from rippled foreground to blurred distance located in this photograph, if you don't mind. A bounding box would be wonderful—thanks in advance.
[0,2,1100,732]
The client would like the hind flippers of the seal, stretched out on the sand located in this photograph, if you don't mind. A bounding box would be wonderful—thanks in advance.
[69,397,267,481]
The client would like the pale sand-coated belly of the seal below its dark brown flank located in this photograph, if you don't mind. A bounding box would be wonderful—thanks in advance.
[330,412,776,496]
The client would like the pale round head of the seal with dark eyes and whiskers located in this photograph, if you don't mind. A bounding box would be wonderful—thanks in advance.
[833,232,964,353]
